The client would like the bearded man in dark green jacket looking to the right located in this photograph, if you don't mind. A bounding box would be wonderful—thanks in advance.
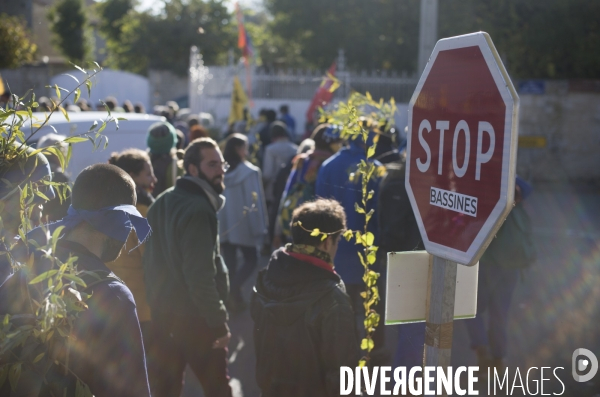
[144,138,231,397]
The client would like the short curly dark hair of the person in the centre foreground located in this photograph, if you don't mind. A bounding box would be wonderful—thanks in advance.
[291,199,346,247]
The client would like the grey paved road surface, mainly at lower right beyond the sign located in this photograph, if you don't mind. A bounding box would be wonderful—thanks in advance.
[184,181,600,397]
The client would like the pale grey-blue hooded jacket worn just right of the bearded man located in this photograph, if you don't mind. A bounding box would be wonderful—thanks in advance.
[218,161,267,247]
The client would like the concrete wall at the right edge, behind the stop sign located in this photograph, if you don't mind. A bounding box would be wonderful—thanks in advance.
[517,81,600,182]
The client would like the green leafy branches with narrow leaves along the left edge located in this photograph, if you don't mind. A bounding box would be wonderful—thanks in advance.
[0,64,117,396]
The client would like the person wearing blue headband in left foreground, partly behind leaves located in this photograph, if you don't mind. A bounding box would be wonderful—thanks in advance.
[0,164,150,397]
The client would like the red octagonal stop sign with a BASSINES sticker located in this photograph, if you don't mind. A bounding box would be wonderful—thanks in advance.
[406,32,519,265]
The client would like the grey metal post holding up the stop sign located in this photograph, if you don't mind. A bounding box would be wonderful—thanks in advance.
[423,256,457,392]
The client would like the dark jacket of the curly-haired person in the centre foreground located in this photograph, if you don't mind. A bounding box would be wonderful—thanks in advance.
[251,248,359,397]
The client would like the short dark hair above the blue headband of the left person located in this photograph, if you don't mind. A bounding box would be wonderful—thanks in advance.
[71,164,137,211]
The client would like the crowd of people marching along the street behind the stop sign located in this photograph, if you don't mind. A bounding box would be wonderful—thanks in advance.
[0,99,530,397]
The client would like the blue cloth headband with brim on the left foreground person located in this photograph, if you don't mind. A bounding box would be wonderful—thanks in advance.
[41,205,152,249]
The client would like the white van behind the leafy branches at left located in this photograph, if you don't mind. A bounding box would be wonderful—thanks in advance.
[22,112,165,180]
